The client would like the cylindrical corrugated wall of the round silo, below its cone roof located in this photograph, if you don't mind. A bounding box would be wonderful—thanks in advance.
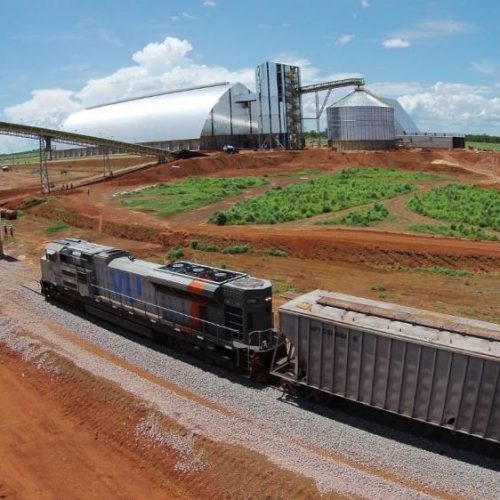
[327,106,395,141]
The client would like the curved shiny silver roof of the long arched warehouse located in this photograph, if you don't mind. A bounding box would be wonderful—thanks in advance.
[63,83,243,143]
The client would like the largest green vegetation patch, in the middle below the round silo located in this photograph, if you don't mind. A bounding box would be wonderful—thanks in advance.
[210,168,438,225]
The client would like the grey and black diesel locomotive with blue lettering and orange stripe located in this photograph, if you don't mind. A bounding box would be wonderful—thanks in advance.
[41,238,283,377]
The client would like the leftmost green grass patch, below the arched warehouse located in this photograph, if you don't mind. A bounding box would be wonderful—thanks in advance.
[121,177,267,217]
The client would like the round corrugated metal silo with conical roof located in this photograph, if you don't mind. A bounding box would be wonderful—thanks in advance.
[327,88,395,151]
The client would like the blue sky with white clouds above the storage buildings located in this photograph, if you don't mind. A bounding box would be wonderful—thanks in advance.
[0,0,500,152]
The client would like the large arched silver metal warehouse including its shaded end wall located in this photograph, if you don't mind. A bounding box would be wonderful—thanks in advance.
[63,83,258,143]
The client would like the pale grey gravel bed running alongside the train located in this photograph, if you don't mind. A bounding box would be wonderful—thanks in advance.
[0,264,500,499]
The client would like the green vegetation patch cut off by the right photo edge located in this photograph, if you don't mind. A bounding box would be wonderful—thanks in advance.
[406,184,500,231]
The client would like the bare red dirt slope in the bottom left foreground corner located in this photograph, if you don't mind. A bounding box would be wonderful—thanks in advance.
[0,344,328,499]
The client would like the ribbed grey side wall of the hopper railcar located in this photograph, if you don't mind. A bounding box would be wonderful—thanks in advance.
[280,311,500,441]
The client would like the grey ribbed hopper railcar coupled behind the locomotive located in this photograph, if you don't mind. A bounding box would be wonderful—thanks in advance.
[271,290,500,442]
